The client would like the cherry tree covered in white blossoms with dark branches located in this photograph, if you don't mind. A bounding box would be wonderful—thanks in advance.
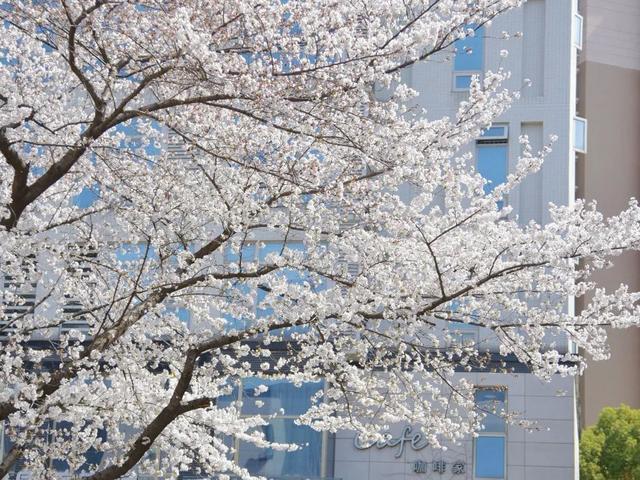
[0,0,640,479]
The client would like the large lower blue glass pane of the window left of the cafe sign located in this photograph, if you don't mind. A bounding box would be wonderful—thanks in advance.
[238,419,322,478]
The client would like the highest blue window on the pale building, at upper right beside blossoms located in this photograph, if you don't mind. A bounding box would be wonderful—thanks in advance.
[453,25,484,92]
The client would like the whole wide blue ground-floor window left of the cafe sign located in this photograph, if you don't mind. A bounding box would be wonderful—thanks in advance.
[218,377,329,478]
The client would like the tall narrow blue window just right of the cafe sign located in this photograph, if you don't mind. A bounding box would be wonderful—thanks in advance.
[473,387,507,480]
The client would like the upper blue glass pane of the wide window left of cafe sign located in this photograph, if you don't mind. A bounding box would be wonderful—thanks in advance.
[242,378,322,415]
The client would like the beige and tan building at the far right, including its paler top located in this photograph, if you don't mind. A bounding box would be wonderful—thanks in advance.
[577,0,640,426]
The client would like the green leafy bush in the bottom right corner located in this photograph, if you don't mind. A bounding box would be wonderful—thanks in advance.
[580,405,640,480]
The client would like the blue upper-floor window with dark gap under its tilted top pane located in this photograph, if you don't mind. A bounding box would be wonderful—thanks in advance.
[476,125,509,208]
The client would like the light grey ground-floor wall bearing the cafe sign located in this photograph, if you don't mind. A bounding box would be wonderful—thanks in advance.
[335,373,576,480]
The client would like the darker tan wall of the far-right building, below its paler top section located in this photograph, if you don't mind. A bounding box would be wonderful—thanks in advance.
[577,58,640,425]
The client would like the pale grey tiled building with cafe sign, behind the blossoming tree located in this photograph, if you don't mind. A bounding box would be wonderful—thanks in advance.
[1,0,585,480]
